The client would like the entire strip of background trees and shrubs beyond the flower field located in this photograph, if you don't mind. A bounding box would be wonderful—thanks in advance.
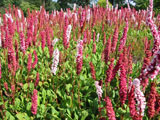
[0,0,160,15]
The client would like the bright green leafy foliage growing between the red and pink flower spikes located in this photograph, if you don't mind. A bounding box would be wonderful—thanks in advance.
[0,0,159,120]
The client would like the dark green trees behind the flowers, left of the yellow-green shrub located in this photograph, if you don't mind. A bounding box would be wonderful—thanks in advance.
[0,0,90,14]
